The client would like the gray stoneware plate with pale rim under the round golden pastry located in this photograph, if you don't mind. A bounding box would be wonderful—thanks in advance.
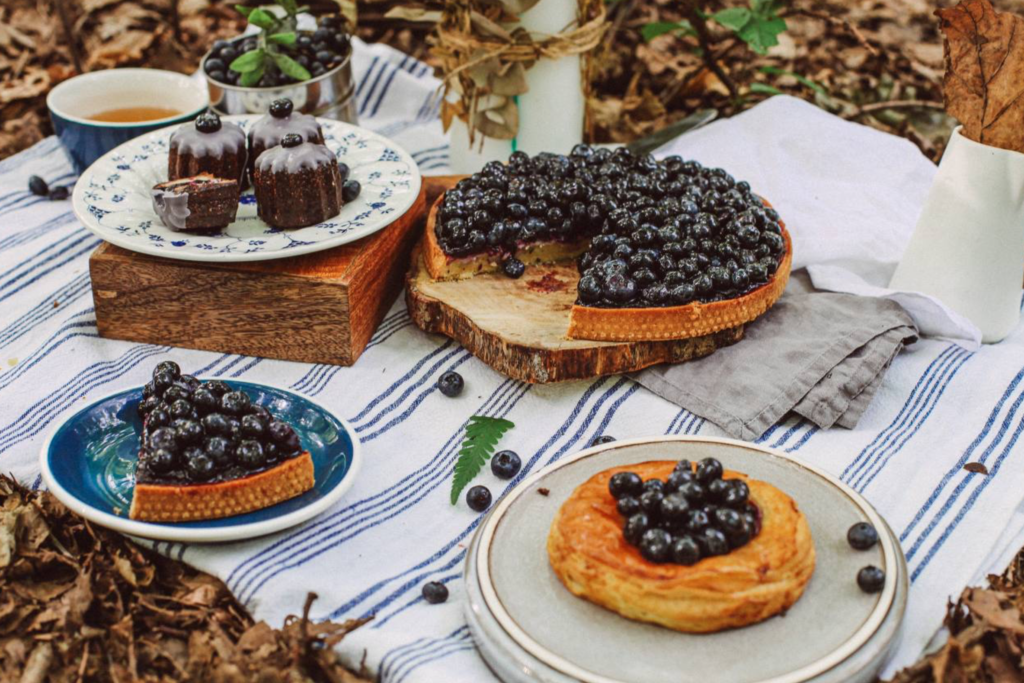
[466,436,907,683]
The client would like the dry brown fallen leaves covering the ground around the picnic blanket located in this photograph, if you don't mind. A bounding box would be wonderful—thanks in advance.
[6,0,1024,683]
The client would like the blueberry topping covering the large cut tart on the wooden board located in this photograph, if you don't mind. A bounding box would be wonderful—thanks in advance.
[436,144,785,307]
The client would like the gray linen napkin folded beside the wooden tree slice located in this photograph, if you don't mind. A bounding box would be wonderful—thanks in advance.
[633,272,918,440]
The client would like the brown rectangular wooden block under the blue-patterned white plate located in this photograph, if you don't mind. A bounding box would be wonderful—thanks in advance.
[95,186,428,366]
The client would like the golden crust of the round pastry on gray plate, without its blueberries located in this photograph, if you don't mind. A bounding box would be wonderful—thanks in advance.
[548,461,815,633]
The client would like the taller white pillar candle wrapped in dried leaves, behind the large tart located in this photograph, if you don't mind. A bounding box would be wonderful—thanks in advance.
[515,0,586,155]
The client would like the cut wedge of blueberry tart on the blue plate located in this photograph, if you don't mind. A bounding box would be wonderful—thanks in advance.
[129,360,313,522]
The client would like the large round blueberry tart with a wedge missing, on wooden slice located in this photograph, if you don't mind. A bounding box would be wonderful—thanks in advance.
[423,145,793,341]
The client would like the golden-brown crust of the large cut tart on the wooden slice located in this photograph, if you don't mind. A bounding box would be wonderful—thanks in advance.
[423,194,793,342]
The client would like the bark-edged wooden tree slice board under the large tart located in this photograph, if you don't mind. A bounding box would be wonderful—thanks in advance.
[406,243,743,384]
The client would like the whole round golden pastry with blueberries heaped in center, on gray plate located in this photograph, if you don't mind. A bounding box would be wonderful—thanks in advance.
[548,461,815,633]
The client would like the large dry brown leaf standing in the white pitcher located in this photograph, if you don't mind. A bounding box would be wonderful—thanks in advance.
[935,0,1024,152]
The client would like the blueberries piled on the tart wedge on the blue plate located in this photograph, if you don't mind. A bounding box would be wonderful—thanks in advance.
[136,360,302,483]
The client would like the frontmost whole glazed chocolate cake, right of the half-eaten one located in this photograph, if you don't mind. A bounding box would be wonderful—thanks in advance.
[253,133,344,227]
